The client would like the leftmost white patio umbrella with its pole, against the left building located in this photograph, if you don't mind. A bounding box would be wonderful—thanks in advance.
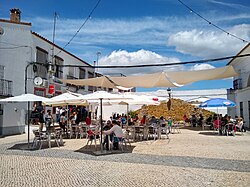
[0,93,49,146]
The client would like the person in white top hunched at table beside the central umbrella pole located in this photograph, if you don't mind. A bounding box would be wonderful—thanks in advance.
[103,120,124,150]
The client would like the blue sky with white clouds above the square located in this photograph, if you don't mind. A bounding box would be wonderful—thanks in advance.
[0,0,250,91]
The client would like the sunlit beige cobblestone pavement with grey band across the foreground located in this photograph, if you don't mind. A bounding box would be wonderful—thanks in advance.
[0,126,250,187]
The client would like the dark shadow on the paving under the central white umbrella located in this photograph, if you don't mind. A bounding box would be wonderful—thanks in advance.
[74,145,136,156]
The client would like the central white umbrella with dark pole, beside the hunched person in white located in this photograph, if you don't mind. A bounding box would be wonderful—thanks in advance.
[81,91,132,151]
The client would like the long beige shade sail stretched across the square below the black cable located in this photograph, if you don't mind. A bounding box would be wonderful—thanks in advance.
[110,66,238,88]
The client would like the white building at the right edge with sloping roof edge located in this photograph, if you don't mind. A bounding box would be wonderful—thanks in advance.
[227,44,250,128]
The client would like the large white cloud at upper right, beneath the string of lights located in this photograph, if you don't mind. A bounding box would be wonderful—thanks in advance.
[168,24,250,58]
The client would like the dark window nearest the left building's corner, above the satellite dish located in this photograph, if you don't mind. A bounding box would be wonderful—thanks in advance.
[35,47,48,79]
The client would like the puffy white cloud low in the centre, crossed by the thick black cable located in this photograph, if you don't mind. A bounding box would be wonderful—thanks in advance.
[99,49,183,76]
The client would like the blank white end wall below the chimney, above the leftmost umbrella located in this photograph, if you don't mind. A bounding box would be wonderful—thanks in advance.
[0,21,32,95]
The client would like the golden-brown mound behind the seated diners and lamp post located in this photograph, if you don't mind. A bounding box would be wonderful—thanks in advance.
[136,99,214,121]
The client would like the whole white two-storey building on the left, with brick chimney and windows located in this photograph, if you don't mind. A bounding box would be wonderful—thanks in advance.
[0,9,95,136]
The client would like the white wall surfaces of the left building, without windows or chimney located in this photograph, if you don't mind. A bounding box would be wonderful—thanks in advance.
[0,20,94,135]
